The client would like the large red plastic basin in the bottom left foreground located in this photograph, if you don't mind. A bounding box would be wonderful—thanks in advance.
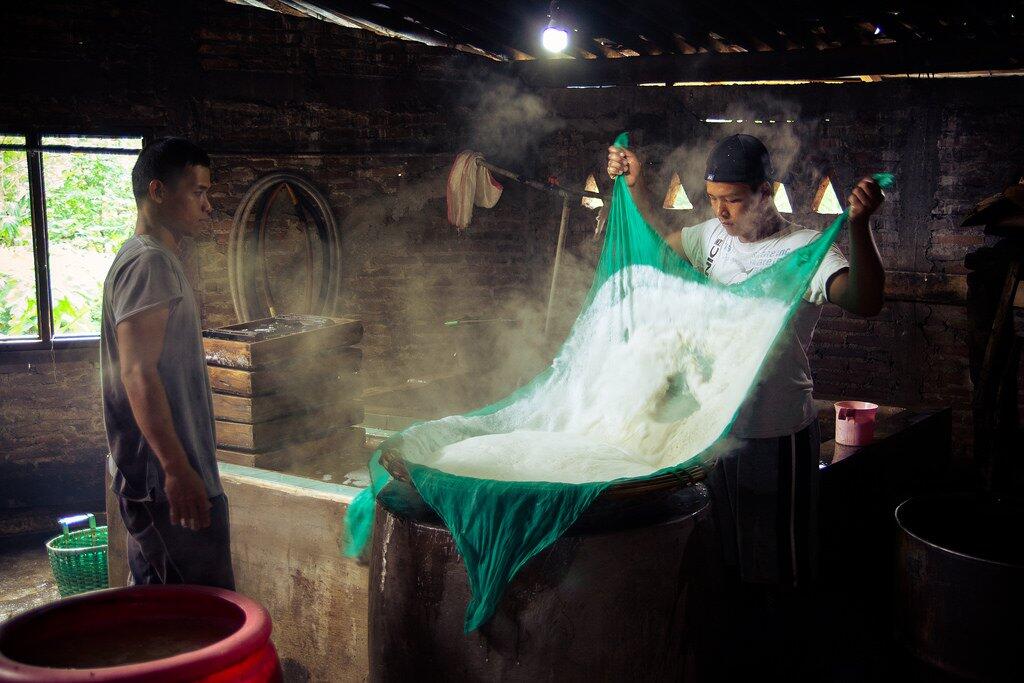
[0,586,281,683]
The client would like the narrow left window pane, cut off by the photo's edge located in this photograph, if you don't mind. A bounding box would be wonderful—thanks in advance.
[0,150,39,339]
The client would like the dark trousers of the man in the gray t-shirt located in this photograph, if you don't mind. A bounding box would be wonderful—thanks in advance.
[119,495,234,591]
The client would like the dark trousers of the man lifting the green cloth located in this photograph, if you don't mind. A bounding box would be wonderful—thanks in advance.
[708,420,820,588]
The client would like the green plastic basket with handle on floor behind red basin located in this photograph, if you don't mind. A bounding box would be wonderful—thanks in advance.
[46,512,110,598]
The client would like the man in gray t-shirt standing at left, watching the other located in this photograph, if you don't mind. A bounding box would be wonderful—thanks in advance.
[100,138,234,588]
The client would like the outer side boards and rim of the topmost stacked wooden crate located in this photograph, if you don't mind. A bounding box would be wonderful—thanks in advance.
[203,318,362,370]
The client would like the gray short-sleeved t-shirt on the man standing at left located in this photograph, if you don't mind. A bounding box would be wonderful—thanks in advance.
[100,234,222,500]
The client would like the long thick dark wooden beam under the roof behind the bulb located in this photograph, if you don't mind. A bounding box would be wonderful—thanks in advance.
[510,41,1024,88]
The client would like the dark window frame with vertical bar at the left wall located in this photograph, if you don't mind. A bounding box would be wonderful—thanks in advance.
[0,128,153,353]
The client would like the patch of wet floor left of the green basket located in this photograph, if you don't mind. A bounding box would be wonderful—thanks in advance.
[0,538,60,623]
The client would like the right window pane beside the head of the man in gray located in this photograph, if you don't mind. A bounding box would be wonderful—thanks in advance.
[43,148,135,337]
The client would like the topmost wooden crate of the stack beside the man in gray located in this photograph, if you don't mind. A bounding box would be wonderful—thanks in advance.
[203,315,362,371]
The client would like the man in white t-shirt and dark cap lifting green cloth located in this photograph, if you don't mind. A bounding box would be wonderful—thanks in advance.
[607,135,885,588]
